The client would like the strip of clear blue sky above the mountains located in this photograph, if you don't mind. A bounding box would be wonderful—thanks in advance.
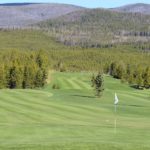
[0,0,150,8]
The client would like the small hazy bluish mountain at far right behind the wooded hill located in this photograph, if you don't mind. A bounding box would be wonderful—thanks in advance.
[112,3,150,15]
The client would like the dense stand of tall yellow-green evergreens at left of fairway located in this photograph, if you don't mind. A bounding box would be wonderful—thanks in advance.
[0,50,48,89]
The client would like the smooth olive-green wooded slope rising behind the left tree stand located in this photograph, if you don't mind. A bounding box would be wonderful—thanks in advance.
[0,30,64,50]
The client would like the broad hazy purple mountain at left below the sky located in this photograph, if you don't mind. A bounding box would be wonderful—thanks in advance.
[0,3,84,28]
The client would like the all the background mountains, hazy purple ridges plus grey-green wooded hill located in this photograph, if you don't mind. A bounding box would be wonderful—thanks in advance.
[0,3,150,47]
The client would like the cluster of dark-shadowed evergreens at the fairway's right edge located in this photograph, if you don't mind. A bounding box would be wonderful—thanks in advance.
[107,62,150,89]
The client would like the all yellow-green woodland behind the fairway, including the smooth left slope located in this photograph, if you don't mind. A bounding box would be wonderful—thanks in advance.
[0,30,150,89]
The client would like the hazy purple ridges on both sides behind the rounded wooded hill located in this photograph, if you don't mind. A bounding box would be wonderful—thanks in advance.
[0,3,150,28]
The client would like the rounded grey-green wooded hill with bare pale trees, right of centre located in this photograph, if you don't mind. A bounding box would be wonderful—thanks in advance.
[38,9,150,46]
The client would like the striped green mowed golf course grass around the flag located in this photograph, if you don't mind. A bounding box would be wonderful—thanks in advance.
[0,73,150,150]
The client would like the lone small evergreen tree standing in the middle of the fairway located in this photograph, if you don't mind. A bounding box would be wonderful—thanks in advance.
[91,72,104,97]
